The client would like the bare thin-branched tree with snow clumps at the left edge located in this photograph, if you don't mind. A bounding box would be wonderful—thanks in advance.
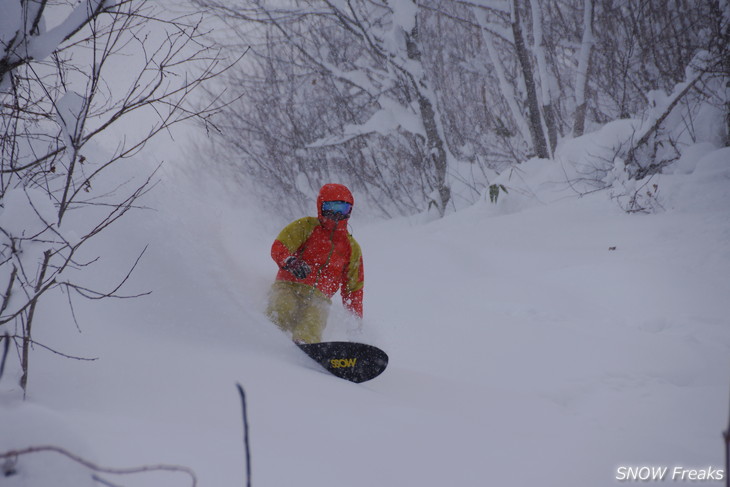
[0,0,226,389]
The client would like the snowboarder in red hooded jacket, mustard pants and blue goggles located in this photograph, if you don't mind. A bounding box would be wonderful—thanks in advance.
[267,184,364,343]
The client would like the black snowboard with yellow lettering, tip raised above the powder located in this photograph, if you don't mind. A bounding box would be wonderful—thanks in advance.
[297,342,388,383]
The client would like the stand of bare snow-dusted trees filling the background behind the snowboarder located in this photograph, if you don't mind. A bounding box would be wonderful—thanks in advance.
[192,0,727,215]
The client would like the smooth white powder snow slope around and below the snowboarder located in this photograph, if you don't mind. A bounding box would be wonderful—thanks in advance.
[0,142,730,487]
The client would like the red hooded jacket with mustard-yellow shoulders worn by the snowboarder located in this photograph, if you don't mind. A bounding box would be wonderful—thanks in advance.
[271,184,364,317]
